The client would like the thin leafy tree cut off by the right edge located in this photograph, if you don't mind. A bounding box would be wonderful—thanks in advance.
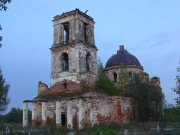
[173,62,180,107]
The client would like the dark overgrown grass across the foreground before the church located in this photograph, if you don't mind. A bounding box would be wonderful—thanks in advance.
[0,122,177,135]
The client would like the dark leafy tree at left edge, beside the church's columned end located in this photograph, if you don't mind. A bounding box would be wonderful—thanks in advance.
[0,69,10,113]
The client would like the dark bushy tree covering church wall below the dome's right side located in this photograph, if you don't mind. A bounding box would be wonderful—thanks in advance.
[124,74,163,122]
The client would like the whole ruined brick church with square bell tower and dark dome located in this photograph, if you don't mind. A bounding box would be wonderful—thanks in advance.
[23,9,160,129]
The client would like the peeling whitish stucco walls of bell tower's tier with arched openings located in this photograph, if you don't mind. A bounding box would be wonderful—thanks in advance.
[51,44,97,86]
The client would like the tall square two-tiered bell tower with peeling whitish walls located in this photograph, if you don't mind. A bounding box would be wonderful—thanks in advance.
[51,9,97,92]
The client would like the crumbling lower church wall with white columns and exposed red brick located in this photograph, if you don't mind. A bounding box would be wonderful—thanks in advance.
[33,93,134,128]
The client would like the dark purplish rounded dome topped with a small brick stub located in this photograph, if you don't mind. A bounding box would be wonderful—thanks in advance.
[105,45,142,69]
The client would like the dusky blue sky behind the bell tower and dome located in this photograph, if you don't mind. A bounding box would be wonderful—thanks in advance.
[0,0,180,111]
